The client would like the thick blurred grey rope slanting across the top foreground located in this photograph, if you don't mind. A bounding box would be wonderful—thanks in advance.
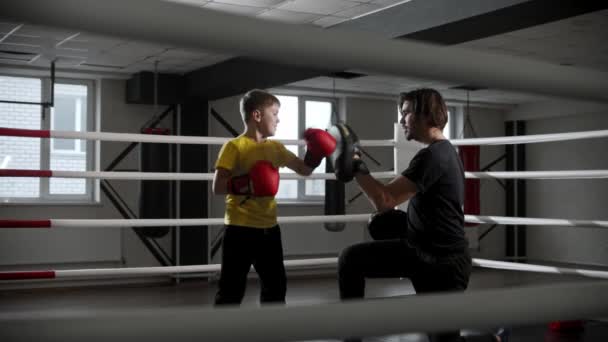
[0,0,608,102]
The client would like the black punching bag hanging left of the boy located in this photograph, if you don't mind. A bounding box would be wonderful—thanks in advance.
[137,128,171,238]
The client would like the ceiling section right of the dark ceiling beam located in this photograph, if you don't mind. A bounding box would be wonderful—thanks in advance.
[290,10,608,104]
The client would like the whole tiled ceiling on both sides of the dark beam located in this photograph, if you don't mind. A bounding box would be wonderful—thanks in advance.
[0,0,608,104]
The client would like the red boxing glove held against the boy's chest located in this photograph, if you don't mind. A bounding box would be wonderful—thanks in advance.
[228,160,279,196]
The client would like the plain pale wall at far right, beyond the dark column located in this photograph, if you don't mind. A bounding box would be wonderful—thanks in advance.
[516,108,608,266]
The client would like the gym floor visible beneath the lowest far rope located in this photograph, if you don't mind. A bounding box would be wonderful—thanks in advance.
[0,268,608,342]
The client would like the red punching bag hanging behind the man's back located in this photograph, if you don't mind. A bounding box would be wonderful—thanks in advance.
[458,145,481,227]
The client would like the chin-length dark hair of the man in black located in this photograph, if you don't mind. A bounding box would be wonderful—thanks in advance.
[399,88,448,130]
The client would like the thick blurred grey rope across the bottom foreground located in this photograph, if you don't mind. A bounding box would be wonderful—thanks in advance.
[0,281,608,342]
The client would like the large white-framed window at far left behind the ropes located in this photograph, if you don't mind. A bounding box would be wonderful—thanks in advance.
[0,76,95,202]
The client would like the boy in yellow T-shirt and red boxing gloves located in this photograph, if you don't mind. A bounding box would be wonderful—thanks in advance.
[213,89,336,305]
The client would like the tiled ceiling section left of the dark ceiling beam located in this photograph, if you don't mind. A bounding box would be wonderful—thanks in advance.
[0,0,409,75]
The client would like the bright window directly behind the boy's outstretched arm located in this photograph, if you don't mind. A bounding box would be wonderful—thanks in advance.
[275,95,335,201]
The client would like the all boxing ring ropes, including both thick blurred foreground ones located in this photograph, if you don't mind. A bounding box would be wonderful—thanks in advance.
[0,0,608,341]
